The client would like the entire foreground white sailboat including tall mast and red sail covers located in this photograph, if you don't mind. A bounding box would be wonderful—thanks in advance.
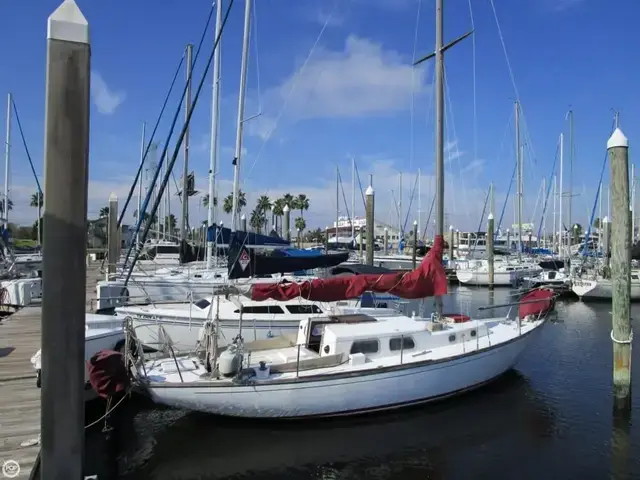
[121,0,553,418]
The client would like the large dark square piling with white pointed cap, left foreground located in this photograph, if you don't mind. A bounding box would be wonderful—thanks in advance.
[40,0,91,480]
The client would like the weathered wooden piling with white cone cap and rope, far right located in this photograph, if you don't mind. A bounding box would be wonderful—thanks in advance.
[607,128,633,410]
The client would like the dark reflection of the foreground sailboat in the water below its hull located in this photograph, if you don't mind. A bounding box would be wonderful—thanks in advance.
[107,371,555,479]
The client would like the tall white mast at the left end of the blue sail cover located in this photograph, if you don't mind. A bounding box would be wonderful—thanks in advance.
[207,0,222,269]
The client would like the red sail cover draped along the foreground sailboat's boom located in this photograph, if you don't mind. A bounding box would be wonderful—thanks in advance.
[251,236,447,302]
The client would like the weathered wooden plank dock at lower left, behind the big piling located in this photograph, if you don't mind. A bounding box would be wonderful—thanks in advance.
[0,264,100,479]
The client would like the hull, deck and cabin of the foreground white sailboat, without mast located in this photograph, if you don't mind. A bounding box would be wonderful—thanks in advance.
[132,290,551,418]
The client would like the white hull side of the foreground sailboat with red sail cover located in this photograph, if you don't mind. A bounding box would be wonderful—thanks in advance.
[146,321,544,418]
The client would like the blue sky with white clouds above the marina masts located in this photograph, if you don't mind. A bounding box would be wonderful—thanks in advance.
[0,0,640,233]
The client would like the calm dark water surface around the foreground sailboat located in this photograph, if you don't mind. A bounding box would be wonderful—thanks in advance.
[87,287,640,480]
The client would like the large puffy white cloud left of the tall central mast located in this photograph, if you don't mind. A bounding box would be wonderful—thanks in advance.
[247,35,428,139]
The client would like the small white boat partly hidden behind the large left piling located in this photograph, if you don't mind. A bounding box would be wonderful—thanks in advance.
[31,313,124,400]
